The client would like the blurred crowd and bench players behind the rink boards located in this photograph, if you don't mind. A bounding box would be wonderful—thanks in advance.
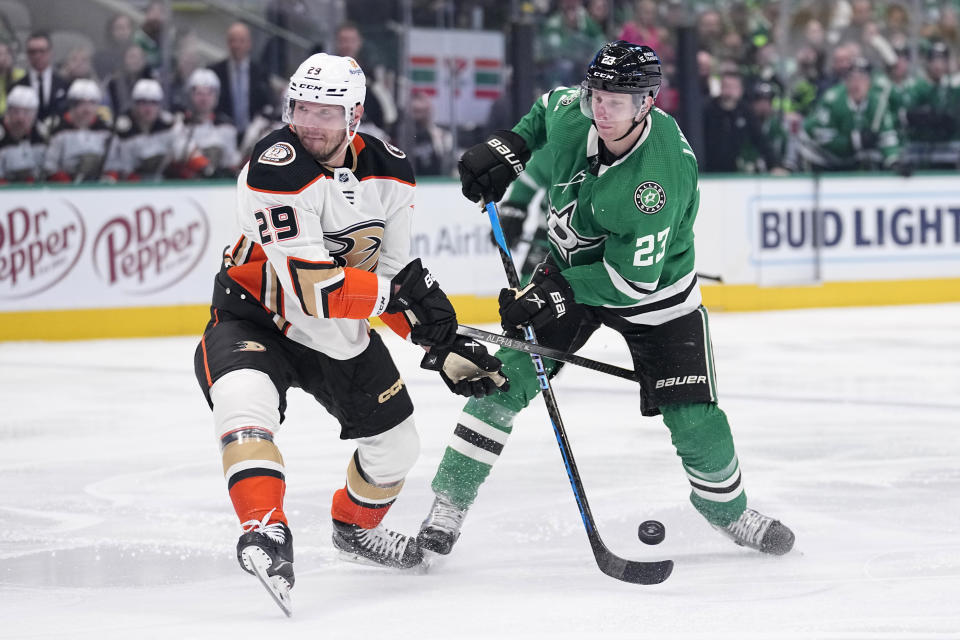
[0,0,960,182]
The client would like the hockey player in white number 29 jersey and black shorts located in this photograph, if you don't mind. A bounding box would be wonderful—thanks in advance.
[195,54,508,614]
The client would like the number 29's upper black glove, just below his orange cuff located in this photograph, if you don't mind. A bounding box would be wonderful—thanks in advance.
[386,258,457,346]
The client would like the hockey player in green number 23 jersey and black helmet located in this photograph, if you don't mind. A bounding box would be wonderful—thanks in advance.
[418,41,794,555]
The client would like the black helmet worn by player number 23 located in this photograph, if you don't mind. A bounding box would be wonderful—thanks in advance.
[584,40,662,99]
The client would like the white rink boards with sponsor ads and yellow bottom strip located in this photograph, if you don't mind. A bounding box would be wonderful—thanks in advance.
[0,174,960,340]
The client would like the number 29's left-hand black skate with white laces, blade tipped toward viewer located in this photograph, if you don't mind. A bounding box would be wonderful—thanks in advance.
[237,511,293,617]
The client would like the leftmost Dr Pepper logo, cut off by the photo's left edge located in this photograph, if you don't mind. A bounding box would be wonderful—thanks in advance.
[0,202,86,300]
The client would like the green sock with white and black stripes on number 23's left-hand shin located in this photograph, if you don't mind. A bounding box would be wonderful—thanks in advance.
[430,398,516,509]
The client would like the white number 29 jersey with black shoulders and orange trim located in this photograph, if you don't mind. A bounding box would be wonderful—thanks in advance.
[214,127,415,360]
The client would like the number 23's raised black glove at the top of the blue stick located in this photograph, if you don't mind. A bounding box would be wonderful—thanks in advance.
[457,129,530,202]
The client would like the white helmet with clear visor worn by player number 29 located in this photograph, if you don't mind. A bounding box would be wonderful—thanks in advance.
[283,53,367,140]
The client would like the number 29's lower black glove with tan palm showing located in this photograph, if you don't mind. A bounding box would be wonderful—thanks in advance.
[420,336,510,398]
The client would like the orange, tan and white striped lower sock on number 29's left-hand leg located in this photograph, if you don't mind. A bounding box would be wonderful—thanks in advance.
[220,427,287,524]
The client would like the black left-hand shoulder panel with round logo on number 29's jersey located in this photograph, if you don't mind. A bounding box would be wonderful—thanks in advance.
[247,127,323,193]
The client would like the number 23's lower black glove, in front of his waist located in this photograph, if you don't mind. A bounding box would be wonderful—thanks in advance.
[500,263,577,333]
